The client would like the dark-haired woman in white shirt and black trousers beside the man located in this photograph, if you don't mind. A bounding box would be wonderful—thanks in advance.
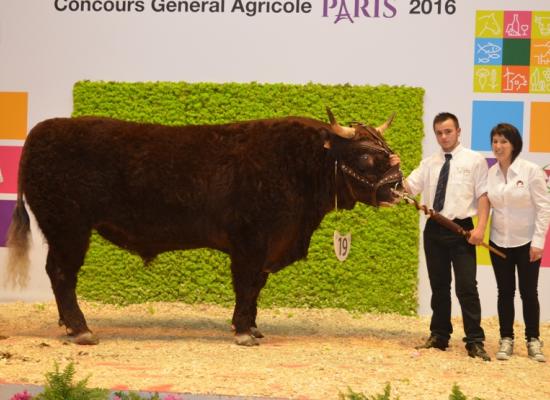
[487,124,550,362]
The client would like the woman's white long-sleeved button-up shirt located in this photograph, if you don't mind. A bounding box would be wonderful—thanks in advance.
[487,157,550,249]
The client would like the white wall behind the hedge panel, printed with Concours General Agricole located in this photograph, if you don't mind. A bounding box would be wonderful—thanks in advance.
[0,0,550,320]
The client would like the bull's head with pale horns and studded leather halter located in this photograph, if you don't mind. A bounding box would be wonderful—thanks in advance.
[327,108,403,206]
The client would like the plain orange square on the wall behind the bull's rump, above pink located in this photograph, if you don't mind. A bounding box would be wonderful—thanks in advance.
[0,92,28,140]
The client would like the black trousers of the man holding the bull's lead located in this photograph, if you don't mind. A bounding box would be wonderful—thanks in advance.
[424,218,485,343]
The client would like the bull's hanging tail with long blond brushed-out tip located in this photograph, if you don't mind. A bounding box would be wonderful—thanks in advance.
[5,193,30,288]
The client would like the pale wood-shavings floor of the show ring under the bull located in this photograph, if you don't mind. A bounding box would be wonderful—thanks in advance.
[0,302,550,400]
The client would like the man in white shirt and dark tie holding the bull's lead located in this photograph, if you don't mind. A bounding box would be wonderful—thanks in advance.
[405,113,490,361]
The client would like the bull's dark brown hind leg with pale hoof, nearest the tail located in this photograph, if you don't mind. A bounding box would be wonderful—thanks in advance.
[46,239,98,344]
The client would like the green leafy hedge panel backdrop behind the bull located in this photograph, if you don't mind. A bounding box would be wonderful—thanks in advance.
[73,81,424,314]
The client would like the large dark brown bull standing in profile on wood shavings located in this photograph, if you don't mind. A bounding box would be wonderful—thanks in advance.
[7,109,403,346]
